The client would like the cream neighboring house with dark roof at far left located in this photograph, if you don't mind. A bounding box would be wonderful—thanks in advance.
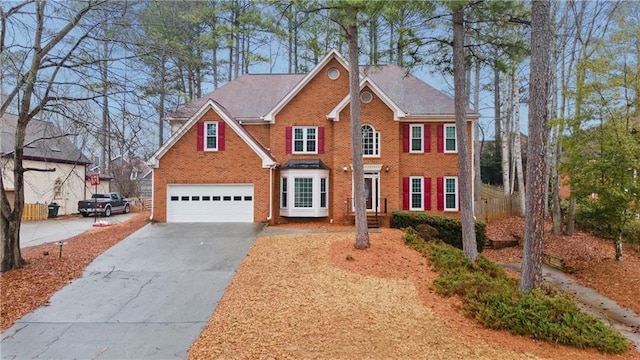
[0,114,90,215]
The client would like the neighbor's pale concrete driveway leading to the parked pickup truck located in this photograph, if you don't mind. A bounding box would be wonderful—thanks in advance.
[20,213,135,248]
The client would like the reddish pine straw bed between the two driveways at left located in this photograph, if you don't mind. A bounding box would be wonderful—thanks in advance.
[0,211,149,331]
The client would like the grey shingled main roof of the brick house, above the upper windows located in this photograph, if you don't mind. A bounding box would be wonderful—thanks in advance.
[166,50,479,123]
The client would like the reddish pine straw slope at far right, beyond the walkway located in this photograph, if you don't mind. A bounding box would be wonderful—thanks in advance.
[484,217,640,314]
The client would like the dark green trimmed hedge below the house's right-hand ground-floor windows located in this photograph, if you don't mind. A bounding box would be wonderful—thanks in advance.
[391,211,487,252]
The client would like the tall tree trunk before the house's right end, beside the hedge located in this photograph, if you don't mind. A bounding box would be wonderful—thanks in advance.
[453,6,478,261]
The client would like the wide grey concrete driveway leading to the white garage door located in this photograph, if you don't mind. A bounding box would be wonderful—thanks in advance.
[1,224,262,359]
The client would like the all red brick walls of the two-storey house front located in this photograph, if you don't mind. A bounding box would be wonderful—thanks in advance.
[154,56,471,223]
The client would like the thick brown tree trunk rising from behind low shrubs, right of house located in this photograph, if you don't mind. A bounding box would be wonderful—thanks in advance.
[520,0,551,293]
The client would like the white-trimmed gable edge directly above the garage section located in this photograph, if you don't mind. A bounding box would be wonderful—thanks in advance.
[152,99,278,168]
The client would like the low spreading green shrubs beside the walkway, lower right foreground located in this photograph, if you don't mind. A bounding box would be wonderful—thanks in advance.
[405,236,629,353]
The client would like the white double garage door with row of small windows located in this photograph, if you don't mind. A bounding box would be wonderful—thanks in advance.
[167,184,253,222]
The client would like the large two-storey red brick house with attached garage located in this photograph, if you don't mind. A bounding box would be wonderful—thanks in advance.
[149,51,478,225]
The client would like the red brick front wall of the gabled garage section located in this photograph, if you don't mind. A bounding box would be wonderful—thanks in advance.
[153,110,269,222]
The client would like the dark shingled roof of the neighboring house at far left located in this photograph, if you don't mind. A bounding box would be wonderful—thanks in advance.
[0,113,91,164]
